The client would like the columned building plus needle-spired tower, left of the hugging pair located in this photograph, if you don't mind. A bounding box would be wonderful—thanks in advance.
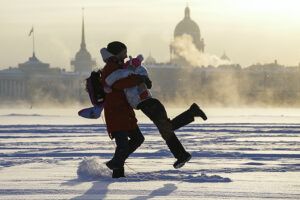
[0,9,96,103]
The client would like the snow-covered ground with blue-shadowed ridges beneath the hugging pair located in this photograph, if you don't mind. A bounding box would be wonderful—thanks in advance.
[0,108,300,200]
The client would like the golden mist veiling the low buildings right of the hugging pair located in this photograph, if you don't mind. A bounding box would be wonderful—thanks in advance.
[149,67,300,107]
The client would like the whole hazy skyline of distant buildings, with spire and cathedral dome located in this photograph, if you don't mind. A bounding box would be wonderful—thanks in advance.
[0,7,300,106]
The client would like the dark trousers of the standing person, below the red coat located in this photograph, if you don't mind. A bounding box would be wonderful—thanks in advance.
[112,128,145,167]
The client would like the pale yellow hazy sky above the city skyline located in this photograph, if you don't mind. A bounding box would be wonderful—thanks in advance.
[0,0,300,70]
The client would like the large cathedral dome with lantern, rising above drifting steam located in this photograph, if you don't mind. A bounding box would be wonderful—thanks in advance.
[174,7,200,41]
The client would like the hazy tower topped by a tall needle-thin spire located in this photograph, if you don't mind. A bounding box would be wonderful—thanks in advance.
[71,8,96,73]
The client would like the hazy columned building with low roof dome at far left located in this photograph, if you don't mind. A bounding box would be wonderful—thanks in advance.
[0,50,83,103]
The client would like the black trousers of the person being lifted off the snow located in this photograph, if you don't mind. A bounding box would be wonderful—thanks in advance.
[138,98,190,159]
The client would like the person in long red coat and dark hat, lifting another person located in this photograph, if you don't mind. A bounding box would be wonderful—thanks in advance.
[102,42,144,178]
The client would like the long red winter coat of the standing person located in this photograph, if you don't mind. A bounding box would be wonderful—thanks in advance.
[102,57,138,138]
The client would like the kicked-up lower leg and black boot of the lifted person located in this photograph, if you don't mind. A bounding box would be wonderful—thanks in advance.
[171,103,207,130]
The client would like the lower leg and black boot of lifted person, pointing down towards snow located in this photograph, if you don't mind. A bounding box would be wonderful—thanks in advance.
[166,134,192,169]
